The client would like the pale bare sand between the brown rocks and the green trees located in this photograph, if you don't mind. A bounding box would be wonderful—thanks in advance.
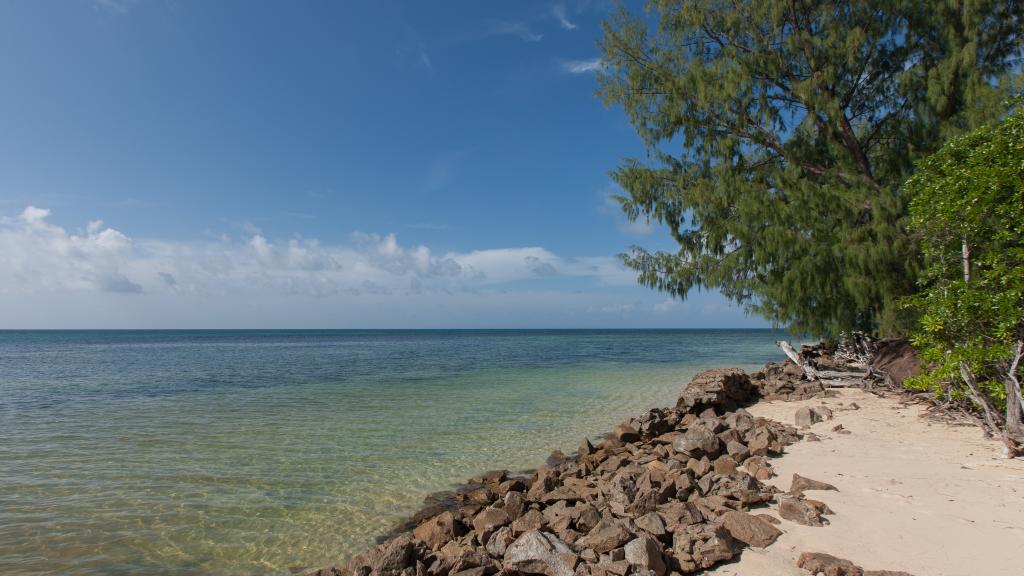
[710,389,1024,576]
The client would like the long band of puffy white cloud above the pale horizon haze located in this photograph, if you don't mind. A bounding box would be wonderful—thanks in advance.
[0,206,633,296]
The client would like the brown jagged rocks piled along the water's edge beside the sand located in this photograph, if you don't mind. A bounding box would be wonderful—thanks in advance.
[312,347,903,576]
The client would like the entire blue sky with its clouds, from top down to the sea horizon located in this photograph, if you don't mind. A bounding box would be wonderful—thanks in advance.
[0,0,766,328]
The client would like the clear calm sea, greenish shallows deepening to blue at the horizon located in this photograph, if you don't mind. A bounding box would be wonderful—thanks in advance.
[0,330,781,575]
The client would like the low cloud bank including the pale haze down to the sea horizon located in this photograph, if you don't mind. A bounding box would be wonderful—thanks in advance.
[0,206,751,328]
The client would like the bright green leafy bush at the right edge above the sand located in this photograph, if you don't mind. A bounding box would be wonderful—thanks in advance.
[904,112,1024,454]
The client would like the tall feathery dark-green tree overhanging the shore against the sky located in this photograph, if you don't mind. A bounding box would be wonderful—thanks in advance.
[598,0,1024,336]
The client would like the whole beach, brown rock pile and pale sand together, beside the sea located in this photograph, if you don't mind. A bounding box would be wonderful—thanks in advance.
[315,344,1024,576]
